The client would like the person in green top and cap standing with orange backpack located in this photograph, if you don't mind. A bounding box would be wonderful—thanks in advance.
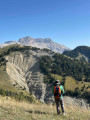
[52,80,65,115]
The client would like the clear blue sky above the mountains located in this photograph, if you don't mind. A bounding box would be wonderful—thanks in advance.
[0,0,90,49]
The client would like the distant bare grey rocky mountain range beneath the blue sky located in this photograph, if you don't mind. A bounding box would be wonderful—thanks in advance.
[0,37,70,53]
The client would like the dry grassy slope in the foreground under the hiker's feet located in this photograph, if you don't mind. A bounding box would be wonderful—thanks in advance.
[0,96,90,120]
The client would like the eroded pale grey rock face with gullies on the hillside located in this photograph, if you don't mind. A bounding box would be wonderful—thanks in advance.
[6,50,52,102]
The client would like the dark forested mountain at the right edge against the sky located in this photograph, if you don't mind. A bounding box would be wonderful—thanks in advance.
[63,46,90,62]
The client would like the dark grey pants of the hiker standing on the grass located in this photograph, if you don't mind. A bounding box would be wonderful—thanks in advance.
[55,98,64,114]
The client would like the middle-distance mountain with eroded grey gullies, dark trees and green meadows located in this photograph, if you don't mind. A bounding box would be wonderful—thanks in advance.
[0,45,90,103]
